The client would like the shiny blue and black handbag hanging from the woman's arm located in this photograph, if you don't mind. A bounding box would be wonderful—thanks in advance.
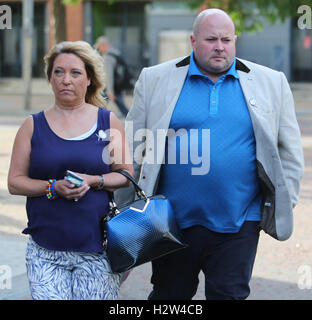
[103,170,187,272]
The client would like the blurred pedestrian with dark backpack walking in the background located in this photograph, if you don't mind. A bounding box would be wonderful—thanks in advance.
[95,36,130,117]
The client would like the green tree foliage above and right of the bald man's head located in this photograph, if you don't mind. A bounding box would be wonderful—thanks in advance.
[189,0,312,34]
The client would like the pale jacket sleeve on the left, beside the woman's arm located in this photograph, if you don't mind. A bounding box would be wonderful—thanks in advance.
[114,68,147,205]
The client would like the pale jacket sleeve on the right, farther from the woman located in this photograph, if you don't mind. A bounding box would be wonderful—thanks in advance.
[278,73,304,207]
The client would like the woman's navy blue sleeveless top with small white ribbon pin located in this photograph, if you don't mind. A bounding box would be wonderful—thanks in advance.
[23,108,110,253]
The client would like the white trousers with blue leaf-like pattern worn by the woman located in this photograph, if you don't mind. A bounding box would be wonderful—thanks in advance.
[26,237,121,300]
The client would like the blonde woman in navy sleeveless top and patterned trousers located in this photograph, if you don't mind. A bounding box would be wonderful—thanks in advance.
[8,41,133,299]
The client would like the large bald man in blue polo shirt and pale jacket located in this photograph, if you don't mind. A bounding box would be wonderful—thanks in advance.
[116,9,303,299]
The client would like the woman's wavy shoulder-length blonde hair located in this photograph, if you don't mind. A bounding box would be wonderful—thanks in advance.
[44,41,106,107]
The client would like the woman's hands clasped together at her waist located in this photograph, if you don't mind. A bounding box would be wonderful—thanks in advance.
[54,179,90,201]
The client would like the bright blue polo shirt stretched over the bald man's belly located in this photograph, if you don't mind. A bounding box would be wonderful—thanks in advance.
[158,53,261,233]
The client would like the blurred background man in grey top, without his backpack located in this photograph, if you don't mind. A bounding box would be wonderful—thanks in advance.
[95,36,128,117]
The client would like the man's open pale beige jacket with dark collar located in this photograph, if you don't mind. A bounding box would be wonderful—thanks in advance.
[115,57,304,240]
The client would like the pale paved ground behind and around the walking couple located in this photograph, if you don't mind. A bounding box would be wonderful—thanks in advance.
[0,81,312,300]
